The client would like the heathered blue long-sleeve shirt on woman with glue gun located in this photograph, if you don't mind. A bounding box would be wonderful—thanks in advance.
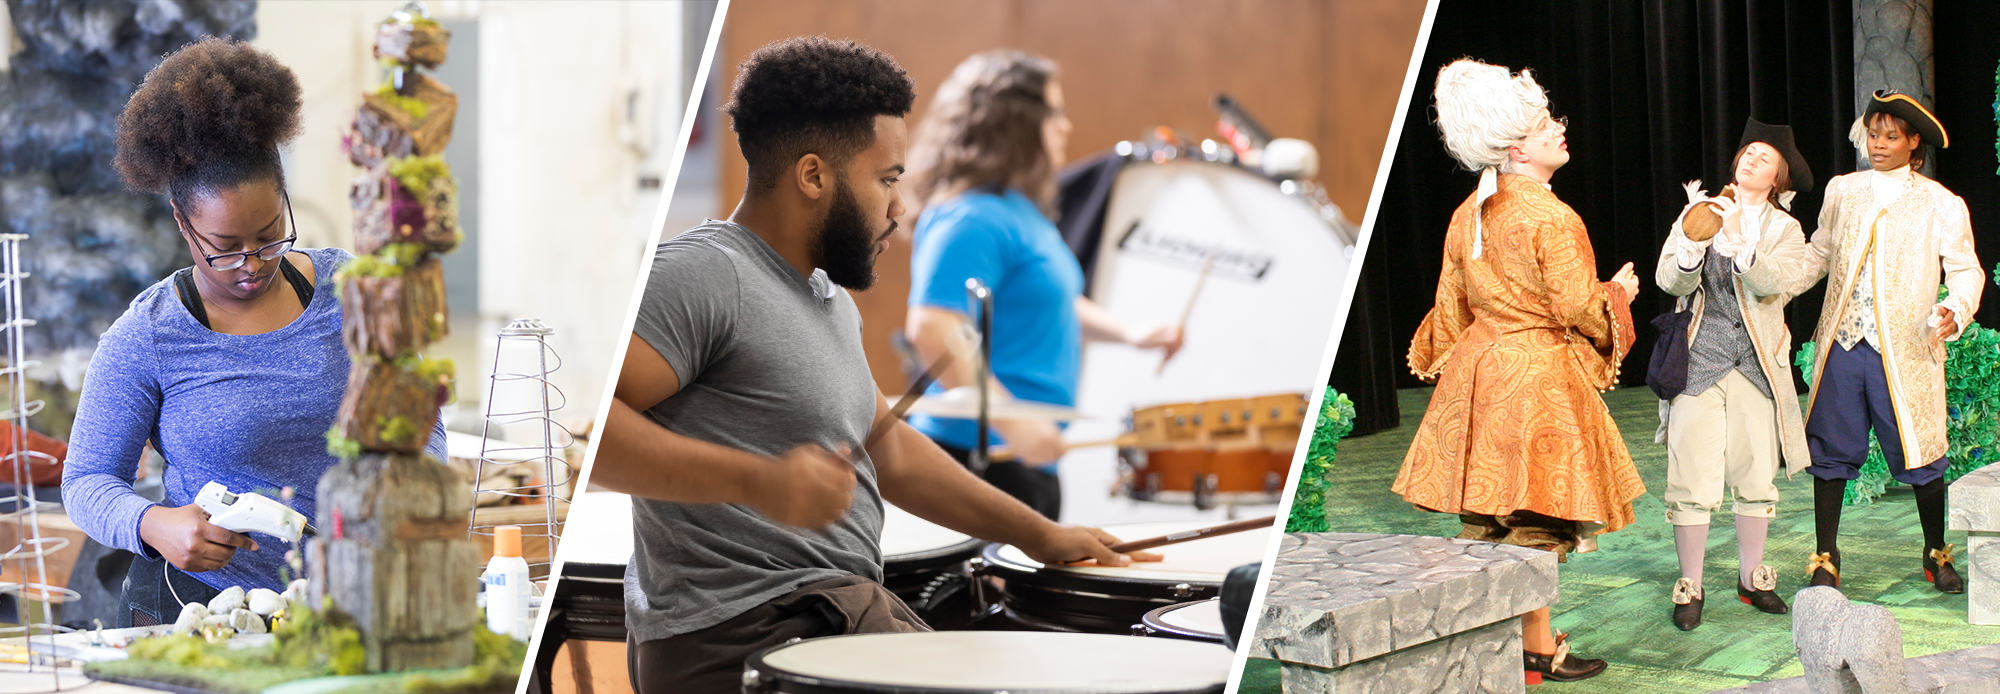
[62,248,444,590]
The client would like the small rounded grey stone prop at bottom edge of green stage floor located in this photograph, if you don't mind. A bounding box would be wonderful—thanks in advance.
[1792,586,1910,694]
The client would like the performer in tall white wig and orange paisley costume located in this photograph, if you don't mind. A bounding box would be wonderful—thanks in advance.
[1394,60,1646,682]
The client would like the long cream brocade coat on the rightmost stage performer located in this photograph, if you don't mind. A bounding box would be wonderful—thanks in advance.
[1806,170,1986,468]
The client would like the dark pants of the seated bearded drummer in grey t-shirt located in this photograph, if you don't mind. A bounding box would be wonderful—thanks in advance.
[626,576,930,694]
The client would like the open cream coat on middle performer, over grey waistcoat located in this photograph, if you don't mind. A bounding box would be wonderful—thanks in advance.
[1654,204,1826,476]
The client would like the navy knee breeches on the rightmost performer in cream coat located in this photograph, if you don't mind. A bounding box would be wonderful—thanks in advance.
[1806,340,1950,486]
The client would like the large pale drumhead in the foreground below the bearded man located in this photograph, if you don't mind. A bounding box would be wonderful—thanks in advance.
[744,632,1230,694]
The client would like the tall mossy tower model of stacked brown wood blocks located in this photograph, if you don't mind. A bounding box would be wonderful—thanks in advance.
[308,8,480,672]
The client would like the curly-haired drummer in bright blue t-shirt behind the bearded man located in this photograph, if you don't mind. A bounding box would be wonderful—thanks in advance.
[904,50,1180,518]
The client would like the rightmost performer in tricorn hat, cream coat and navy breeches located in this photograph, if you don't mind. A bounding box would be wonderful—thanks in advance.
[1806,92,1986,594]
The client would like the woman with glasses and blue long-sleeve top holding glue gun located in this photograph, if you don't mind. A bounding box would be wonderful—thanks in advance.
[62,38,444,624]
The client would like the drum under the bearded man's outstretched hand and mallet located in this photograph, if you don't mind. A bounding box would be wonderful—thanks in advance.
[984,522,1272,634]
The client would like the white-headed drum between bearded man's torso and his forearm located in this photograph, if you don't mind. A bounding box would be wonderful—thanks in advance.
[882,504,986,630]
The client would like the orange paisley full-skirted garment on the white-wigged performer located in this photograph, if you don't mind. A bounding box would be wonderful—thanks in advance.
[1392,174,1646,536]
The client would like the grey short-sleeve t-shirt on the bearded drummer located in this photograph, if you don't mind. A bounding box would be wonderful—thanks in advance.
[626,220,882,642]
